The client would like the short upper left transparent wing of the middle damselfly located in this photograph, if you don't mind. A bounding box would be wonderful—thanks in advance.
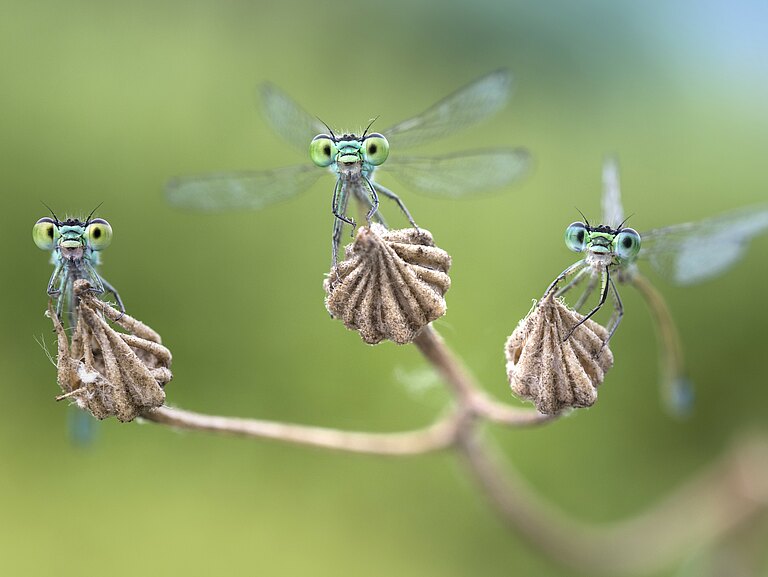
[260,83,328,153]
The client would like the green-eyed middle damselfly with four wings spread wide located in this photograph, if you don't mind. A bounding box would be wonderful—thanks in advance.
[166,70,529,264]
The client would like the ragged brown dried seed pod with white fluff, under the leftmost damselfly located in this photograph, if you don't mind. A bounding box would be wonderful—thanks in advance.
[48,280,172,421]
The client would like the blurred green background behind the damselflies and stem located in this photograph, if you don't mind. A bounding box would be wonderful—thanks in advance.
[0,0,768,577]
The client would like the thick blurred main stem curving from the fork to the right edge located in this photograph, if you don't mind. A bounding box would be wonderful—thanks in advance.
[459,434,768,576]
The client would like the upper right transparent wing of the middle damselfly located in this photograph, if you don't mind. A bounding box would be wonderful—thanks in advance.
[383,70,512,150]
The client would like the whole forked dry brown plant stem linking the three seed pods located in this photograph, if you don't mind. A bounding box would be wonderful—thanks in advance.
[143,326,768,577]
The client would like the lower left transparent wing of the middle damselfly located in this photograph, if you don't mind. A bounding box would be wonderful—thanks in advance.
[165,165,325,211]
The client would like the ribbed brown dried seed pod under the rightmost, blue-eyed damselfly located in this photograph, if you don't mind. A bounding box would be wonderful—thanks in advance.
[505,292,613,415]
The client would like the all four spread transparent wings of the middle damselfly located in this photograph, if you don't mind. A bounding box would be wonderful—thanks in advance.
[166,70,529,211]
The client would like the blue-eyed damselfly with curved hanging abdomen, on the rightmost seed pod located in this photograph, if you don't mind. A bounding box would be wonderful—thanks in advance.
[545,159,768,412]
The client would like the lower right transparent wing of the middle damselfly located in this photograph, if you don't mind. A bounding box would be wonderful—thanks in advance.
[386,148,530,198]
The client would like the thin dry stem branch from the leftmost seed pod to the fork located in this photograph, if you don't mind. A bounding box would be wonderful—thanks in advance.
[142,407,458,456]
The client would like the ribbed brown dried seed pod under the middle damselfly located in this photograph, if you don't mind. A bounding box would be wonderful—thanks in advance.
[323,224,451,344]
